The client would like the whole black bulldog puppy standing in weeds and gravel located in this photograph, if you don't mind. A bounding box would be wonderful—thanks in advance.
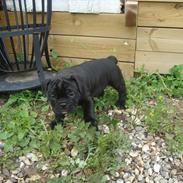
[45,56,126,129]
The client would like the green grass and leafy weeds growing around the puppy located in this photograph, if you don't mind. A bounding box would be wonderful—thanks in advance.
[0,65,183,183]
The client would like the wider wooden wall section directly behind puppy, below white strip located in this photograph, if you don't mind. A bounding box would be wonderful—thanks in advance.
[49,12,136,78]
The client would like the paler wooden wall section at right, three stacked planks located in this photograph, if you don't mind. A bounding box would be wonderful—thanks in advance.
[135,0,183,73]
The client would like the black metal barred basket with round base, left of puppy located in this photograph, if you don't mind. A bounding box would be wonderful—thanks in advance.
[0,0,53,92]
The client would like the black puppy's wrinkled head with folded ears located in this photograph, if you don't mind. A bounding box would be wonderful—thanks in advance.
[45,76,80,115]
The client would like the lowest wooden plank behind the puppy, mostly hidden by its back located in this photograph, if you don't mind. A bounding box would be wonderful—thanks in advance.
[54,57,134,79]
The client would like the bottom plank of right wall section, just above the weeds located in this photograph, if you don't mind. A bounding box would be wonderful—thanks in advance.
[135,51,183,74]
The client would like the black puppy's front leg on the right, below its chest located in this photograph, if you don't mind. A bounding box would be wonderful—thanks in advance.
[83,97,98,129]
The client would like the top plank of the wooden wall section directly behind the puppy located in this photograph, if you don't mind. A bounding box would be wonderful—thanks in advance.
[51,12,136,39]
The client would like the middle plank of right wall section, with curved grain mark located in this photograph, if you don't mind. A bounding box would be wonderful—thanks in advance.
[137,27,183,53]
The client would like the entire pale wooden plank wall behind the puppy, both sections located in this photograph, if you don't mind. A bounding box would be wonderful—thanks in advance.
[0,0,183,78]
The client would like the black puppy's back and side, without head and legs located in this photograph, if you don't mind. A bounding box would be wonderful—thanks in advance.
[58,56,122,97]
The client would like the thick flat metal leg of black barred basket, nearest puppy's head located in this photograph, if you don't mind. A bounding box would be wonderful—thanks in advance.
[33,33,45,93]
